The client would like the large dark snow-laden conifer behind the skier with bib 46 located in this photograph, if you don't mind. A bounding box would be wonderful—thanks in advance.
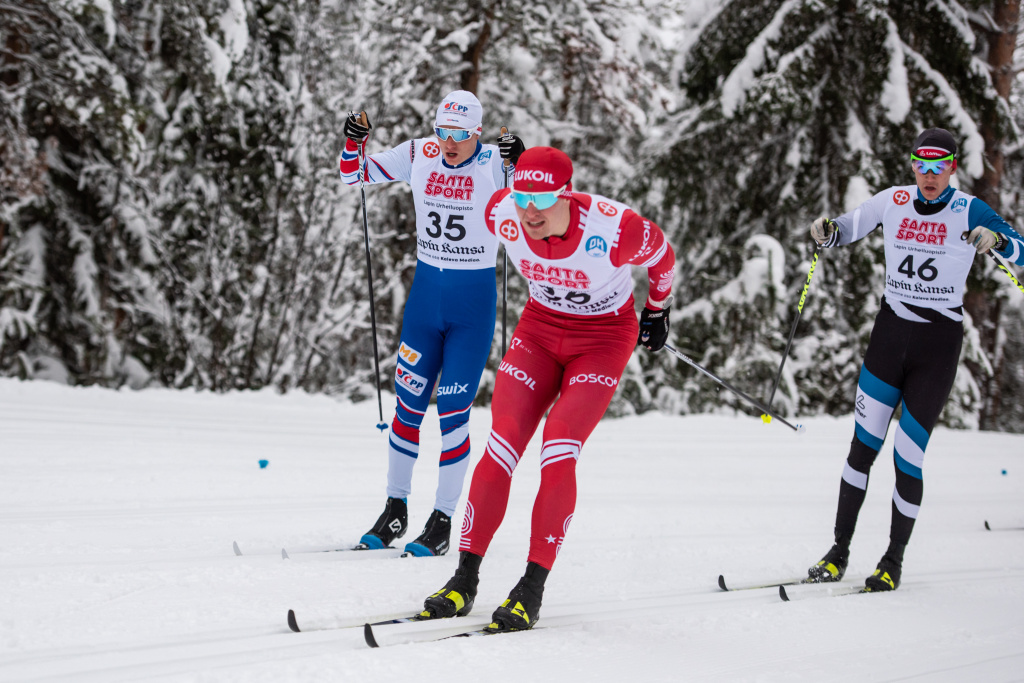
[637,0,1019,424]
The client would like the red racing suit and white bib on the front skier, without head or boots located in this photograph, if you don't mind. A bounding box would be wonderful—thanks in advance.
[460,189,676,569]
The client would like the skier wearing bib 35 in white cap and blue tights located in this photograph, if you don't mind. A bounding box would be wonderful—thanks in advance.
[340,90,524,556]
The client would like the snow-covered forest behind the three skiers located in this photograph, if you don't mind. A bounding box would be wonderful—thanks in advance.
[6,0,1024,432]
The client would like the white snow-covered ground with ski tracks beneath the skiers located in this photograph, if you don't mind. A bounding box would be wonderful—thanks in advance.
[0,380,1024,683]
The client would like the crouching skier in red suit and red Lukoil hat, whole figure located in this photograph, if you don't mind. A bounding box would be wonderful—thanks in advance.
[424,147,675,631]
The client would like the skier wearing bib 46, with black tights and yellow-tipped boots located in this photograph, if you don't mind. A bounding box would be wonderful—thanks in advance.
[808,128,1024,591]
